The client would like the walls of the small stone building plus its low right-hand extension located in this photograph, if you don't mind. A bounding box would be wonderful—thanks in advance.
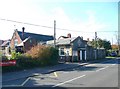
[58,38,105,62]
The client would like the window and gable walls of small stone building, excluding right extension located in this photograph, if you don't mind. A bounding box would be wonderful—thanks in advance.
[58,37,85,62]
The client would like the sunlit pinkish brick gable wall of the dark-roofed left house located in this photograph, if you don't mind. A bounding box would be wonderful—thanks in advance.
[10,31,22,49]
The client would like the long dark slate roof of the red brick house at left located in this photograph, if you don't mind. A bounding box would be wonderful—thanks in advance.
[17,31,54,41]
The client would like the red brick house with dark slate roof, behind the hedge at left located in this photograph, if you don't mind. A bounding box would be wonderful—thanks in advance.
[10,27,54,52]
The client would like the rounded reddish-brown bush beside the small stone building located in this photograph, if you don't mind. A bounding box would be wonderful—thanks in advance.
[26,45,59,65]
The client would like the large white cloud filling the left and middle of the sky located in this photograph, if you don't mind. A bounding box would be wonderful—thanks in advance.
[0,0,116,43]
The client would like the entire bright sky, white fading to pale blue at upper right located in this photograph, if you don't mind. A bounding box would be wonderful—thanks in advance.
[0,0,118,44]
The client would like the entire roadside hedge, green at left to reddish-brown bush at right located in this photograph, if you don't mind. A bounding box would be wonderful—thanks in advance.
[2,46,58,72]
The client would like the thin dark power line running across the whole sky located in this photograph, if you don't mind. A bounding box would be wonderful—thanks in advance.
[0,18,118,33]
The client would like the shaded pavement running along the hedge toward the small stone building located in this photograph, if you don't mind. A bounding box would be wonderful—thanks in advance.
[0,59,116,82]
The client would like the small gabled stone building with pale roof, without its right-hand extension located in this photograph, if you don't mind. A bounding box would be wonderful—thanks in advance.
[47,34,87,61]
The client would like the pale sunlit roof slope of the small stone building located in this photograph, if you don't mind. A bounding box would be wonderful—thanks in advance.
[47,37,77,45]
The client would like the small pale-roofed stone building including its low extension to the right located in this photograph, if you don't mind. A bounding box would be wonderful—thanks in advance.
[47,34,104,62]
